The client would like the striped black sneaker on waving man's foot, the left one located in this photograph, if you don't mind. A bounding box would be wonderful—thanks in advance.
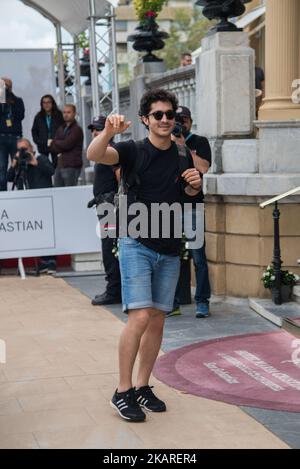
[110,388,146,422]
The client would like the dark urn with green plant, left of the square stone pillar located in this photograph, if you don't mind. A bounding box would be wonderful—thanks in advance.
[128,0,169,62]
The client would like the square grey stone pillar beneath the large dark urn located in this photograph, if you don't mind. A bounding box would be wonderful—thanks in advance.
[196,32,255,138]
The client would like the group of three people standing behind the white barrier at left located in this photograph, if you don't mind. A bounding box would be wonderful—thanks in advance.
[0,78,83,191]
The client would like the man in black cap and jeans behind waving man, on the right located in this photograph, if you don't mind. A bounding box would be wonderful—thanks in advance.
[168,106,211,318]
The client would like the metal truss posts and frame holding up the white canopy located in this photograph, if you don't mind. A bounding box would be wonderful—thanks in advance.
[21,0,119,117]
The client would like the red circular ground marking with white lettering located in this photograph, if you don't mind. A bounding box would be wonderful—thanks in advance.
[154,331,300,412]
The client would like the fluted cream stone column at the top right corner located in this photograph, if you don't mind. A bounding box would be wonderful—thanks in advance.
[259,0,300,121]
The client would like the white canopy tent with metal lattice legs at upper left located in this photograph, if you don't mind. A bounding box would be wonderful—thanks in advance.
[21,0,119,116]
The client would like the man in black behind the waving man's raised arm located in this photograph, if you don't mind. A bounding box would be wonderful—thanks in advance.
[88,116,121,306]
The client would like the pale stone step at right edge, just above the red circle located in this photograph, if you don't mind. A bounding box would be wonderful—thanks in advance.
[249,298,300,327]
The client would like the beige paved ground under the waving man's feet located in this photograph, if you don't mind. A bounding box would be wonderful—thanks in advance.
[0,277,287,449]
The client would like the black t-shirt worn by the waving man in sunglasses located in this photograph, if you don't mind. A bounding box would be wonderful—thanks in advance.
[114,138,194,256]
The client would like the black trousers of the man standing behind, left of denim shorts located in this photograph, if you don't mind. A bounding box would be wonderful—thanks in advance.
[102,234,121,298]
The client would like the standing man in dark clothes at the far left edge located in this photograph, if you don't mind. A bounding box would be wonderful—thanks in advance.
[0,78,25,191]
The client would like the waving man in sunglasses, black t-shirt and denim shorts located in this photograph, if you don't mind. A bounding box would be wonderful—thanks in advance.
[88,89,201,421]
